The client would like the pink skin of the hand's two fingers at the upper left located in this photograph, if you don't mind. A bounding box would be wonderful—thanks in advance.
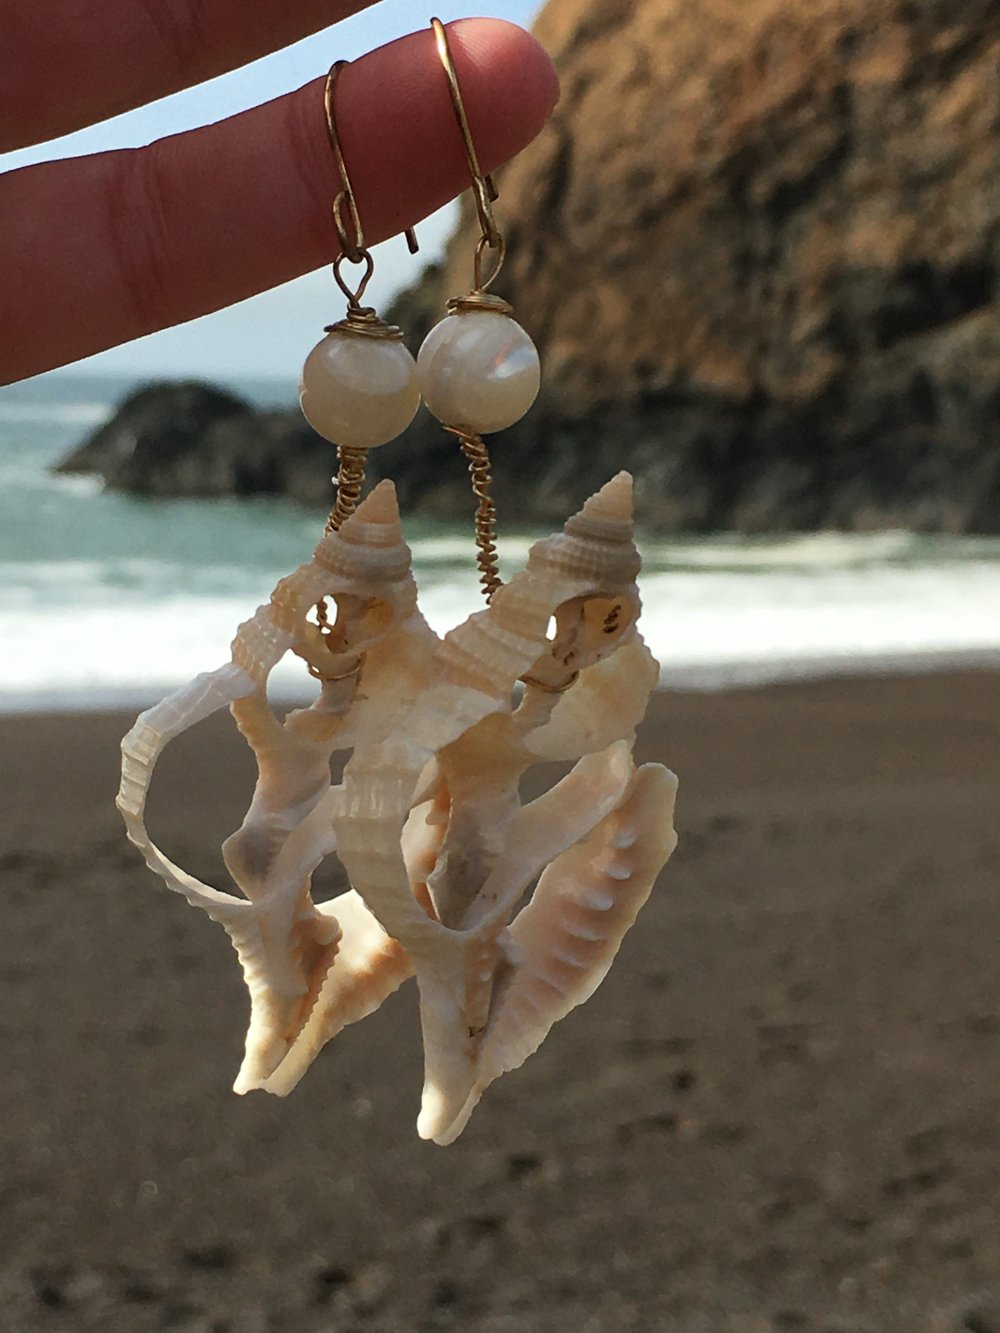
[0,14,559,383]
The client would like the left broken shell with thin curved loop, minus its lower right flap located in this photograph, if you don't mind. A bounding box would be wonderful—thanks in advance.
[117,481,437,1092]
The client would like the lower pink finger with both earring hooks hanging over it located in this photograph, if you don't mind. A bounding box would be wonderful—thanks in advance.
[0,19,557,383]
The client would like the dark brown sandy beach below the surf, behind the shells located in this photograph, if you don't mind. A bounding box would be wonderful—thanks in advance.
[0,672,1000,1333]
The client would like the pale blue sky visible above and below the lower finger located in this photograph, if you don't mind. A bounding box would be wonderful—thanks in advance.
[0,0,543,380]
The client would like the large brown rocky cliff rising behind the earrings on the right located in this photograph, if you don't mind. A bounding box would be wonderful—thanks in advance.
[56,0,1000,532]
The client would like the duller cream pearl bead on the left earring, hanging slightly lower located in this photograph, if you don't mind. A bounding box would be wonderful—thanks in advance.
[299,329,420,449]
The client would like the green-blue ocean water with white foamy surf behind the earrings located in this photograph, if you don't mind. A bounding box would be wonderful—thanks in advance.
[0,372,1000,710]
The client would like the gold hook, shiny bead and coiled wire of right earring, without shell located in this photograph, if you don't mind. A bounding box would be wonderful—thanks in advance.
[417,19,541,601]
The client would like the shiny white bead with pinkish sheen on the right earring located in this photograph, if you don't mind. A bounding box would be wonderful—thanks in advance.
[417,311,541,435]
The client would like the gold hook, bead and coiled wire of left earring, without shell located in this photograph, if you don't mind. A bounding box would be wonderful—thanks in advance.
[299,60,420,531]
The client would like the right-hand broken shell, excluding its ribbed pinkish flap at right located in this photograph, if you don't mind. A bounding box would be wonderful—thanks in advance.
[333,473,668,1141]
